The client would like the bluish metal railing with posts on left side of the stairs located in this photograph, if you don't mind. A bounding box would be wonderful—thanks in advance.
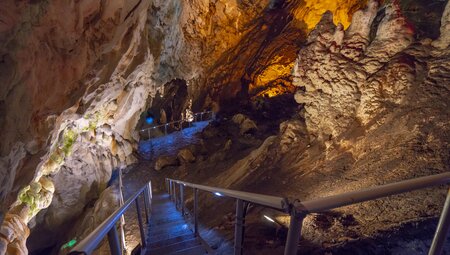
[69,182,152,255]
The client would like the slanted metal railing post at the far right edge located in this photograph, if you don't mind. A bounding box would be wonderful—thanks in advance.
[428,189,450,255]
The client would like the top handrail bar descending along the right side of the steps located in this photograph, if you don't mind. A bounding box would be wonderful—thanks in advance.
[167,178,289,211]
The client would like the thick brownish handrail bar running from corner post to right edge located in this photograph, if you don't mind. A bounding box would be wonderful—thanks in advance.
[295,173,450,213]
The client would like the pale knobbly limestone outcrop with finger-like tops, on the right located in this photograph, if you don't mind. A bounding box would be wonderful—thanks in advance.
[294,1,414,140]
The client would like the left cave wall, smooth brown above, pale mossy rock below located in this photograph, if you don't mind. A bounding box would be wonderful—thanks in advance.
[0,1,155,251]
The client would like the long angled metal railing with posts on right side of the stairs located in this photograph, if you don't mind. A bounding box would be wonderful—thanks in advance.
[166,173,450,255]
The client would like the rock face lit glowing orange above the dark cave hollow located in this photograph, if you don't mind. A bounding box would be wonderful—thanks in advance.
[206,0,366,101]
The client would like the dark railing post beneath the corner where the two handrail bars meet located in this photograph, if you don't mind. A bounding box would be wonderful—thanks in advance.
[284,208,306,255]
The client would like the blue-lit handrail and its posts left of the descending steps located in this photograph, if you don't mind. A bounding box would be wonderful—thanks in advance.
[69,182,151,255]
